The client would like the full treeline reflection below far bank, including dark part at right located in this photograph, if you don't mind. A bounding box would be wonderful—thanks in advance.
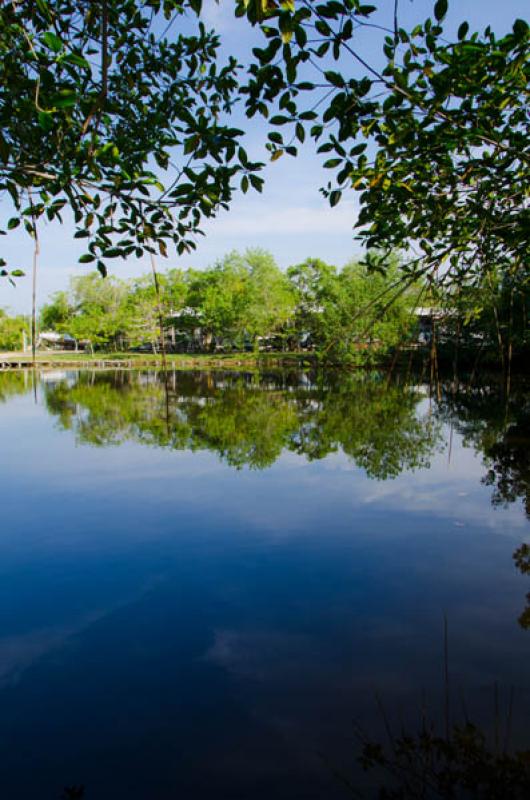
[31,371,530,506]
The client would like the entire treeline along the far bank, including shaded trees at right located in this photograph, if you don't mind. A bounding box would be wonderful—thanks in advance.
[0,249,530,367]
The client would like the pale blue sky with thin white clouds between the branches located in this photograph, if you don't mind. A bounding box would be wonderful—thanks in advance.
[0,0,528,313]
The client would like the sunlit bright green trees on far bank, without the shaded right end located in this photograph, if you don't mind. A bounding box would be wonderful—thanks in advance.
[36,249,416,356]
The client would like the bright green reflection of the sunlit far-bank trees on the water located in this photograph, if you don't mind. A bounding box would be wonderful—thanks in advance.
[36,372,440,479]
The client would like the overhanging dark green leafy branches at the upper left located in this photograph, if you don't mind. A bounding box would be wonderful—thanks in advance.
[0,0,261,282]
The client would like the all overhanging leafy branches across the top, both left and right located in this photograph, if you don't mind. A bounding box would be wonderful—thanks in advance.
[0,0,530,296]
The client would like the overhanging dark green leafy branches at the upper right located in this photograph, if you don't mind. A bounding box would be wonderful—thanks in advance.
[238,0,530,294]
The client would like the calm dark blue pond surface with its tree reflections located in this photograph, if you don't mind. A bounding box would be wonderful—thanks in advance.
[0,372,530,800]
